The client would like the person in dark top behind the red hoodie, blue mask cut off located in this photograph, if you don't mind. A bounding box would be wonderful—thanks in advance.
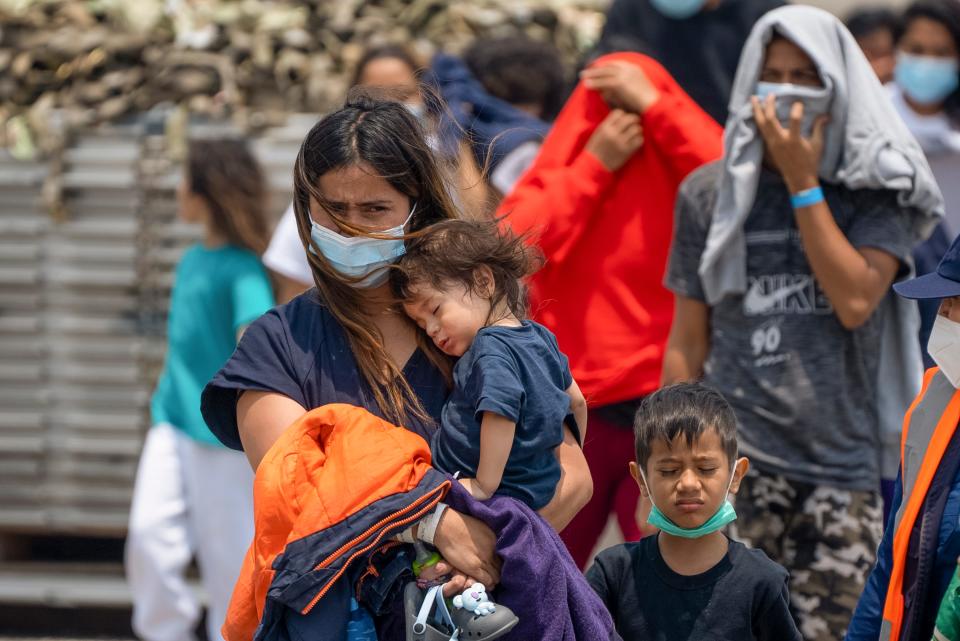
[600,0,784,123]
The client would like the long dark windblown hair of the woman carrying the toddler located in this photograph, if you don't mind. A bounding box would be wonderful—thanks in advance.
[293,91,459,423]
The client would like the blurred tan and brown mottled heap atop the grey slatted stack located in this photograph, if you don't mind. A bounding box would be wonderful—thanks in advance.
[0,0,608,155]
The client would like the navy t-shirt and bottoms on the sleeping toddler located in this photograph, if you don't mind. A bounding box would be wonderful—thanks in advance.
[430,321,573,510]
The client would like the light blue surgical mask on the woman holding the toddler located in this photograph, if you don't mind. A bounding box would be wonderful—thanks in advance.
[310,203,417,288]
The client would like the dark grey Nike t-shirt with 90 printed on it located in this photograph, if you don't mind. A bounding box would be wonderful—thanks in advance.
[665,162,911,490]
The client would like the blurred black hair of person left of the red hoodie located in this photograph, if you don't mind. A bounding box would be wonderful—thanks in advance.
[463,35,567,121]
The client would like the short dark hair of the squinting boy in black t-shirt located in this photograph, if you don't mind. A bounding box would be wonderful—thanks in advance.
[633,383,737,470]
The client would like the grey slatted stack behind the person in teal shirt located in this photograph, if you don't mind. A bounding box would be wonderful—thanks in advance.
[0,116,315,535]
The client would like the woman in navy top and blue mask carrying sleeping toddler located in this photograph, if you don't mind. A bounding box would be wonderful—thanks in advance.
[202,96,591,638]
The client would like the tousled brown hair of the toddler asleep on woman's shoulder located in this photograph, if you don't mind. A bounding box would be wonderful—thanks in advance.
[390,219,542,320]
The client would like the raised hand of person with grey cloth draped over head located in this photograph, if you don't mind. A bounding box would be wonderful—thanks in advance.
[750,95,829,194]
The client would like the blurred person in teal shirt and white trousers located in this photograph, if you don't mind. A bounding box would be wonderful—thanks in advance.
[126,140,274,641]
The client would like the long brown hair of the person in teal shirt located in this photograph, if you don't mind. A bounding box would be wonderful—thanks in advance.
[187,139,270,256]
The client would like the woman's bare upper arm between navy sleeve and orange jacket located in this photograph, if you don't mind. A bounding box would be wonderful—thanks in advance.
[237,390,307,470]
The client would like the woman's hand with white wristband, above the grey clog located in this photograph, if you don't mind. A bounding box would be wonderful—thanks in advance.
[433,509,501,589]
